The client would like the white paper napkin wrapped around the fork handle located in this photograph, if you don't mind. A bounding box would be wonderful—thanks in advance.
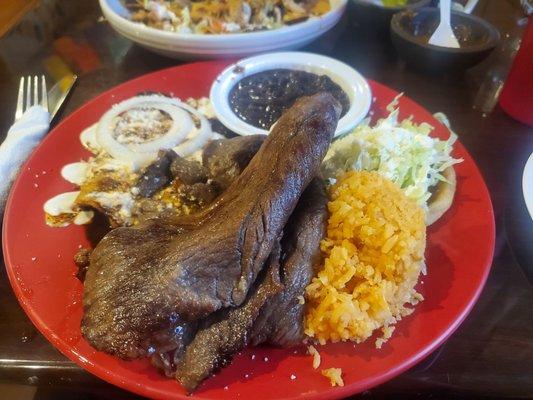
[0,106,50,215]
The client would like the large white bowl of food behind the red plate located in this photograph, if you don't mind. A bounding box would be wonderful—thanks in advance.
[100,0,347,59]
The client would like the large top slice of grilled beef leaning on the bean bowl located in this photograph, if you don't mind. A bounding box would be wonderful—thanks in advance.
[81,93,340,359]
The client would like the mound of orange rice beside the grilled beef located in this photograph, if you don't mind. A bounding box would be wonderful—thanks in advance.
[305,171,426,347]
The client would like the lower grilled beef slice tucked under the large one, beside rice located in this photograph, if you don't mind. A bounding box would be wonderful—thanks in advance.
[175,179,327,392]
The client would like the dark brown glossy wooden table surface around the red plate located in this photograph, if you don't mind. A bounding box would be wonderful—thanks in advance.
[0,0,533,399]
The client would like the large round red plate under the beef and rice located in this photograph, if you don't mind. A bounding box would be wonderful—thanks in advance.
[3,62,494,399]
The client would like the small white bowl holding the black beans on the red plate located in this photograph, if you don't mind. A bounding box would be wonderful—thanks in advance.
[210,52,372,136]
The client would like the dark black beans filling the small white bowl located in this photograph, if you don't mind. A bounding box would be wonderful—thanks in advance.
[229,69,350,130]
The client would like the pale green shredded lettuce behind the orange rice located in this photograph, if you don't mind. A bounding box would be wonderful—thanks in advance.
[322,99,463,209]
